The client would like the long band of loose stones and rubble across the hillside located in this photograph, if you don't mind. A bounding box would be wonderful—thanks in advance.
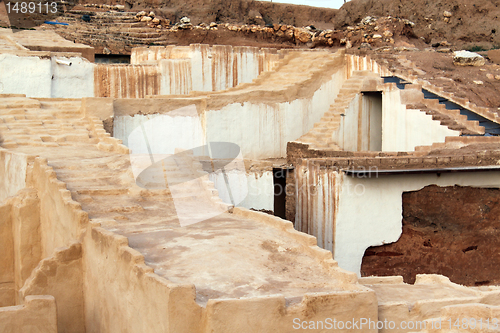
[39,9,416,54]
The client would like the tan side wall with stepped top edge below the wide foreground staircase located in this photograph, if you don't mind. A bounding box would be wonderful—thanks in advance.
[83,223,202,333]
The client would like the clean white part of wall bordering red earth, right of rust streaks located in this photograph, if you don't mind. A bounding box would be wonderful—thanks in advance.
[335,172,500,275]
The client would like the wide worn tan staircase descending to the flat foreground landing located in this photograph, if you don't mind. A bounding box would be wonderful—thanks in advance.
[0,95,355,304]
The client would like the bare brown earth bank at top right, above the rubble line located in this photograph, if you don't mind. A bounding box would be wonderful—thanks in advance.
[334,0,500,49]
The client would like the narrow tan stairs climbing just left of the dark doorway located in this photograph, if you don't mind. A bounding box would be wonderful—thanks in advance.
[297,71,377,150]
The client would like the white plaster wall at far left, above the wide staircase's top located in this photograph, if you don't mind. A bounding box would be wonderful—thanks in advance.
[0,53,94,98]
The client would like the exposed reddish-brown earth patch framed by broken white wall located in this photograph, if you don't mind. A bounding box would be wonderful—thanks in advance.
[361,185,500,286]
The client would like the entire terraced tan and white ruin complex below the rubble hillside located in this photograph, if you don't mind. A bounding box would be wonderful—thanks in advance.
[0,29,500,333]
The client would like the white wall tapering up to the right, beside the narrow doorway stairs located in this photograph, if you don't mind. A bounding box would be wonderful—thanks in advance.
[205,70,344,159]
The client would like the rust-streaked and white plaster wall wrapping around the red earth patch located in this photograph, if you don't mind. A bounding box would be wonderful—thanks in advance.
[296,165,500,275]
